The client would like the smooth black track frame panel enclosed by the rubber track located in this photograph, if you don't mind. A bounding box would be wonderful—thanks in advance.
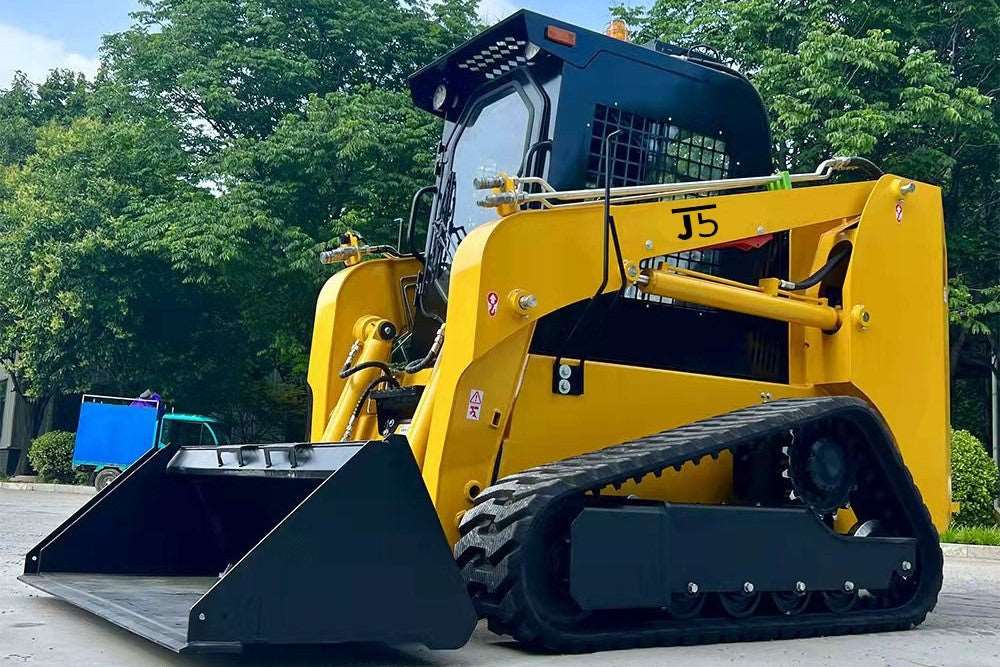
[570,503,916,609]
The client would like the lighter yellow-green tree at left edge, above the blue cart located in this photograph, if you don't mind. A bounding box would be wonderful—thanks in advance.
[0,118,211,472]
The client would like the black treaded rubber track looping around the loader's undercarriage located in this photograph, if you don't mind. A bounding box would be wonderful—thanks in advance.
[455,397,943,652]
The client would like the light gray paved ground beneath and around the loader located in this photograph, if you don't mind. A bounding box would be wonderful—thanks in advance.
[0,489,1000,667]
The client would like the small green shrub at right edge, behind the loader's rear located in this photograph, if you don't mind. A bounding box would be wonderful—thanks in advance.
[951,431,1000,526]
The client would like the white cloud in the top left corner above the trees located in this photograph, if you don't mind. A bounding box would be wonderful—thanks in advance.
[0,23,99,89]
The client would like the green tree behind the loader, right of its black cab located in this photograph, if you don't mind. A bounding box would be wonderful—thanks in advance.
[614,0,1000,434]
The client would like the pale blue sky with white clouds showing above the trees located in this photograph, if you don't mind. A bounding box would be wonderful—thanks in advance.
[0,0,649,88]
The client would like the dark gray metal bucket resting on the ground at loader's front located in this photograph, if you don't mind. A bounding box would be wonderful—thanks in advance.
[20,437,476,652]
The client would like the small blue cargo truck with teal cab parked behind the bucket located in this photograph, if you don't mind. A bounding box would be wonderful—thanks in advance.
[73,394,228,491]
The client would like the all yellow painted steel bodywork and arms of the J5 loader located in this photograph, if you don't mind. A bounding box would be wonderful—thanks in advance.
[310,176,951,540]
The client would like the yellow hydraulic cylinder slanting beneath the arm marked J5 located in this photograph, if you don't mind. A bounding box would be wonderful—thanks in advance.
[638,270,840,331]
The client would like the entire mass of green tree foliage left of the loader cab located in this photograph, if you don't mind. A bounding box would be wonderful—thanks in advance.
[0,5,479,446]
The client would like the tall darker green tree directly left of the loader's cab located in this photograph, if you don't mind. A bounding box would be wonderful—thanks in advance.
[86,0,478,437]
